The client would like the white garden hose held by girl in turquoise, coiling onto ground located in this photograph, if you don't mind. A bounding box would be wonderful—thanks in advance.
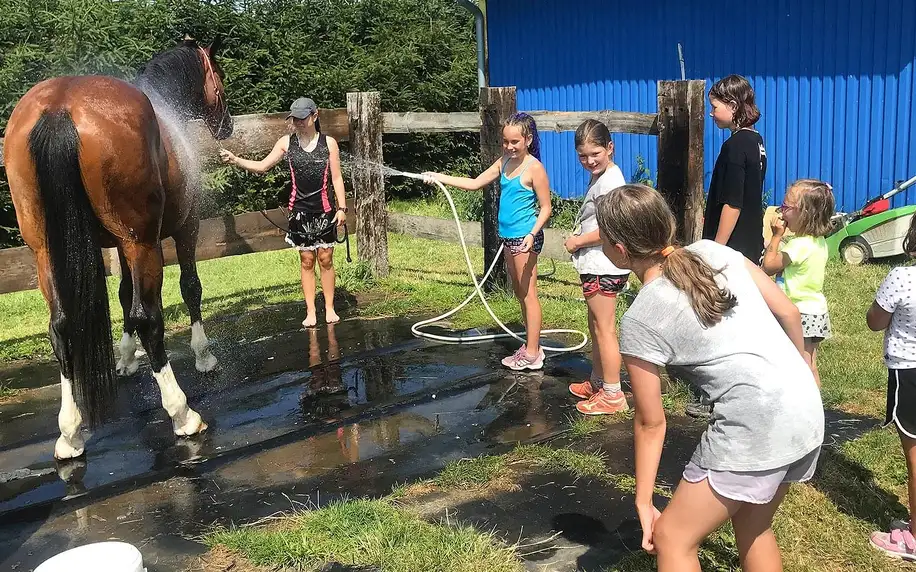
[396,171,588,352]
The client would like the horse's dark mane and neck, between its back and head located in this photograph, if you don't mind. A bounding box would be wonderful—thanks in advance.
[134,40,204,120]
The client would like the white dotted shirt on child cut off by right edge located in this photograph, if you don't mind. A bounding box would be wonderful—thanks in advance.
[875,266,916,369]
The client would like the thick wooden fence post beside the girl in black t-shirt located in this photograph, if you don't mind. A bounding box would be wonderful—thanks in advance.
[658,80,706,244]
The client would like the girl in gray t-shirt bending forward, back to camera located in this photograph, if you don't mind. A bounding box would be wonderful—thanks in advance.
[598,185,824,572]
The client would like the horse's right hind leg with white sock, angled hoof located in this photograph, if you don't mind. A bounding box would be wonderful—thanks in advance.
[123,243,207,435]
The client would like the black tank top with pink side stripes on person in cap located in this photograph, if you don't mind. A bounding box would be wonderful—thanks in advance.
[286,133,334,213]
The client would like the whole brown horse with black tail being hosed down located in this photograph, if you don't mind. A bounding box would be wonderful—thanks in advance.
[4,39,232,459]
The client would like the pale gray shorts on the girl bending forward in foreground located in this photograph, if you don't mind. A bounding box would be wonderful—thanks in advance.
[684,447,821,504]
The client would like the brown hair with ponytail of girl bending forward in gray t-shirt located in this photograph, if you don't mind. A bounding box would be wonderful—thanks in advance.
[597,185,738,328]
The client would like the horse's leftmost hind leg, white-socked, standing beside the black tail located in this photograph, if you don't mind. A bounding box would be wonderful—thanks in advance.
[36,250,85,459]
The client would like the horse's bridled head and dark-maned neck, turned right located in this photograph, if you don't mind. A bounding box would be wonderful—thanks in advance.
[136,37,233,140]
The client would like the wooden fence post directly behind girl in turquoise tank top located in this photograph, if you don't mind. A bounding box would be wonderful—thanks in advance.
[480,87,516,292]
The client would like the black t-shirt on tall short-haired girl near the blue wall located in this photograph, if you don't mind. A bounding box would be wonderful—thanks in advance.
[703,129,767,264]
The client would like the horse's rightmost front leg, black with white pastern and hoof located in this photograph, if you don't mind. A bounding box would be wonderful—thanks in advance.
[173,213,217,373]
